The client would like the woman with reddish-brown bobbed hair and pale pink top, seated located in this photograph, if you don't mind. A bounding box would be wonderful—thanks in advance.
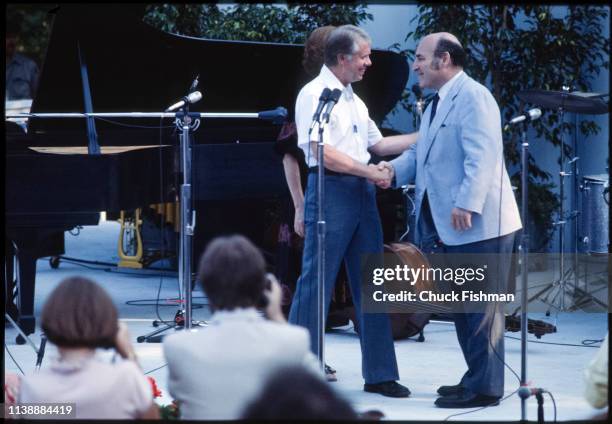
[18,277,159,419]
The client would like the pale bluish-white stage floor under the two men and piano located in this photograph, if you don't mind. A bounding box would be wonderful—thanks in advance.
[4,222,608,421]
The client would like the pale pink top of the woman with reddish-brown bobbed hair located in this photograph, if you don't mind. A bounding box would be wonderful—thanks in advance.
[18,356,153,420]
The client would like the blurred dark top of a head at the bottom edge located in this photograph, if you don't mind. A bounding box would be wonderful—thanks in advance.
[242,367,358,422]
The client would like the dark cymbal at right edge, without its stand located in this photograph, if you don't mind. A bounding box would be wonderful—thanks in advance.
[518,89,608,115]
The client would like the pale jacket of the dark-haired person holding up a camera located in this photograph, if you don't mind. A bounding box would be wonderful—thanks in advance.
[163,308,323,420]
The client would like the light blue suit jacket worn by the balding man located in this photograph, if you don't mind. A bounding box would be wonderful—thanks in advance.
[391,73,521,246]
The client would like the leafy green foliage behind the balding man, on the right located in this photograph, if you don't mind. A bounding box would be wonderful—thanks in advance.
[402,4,610,250]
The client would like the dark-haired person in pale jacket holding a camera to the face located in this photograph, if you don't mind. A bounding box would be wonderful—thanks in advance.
[163,235,323,420]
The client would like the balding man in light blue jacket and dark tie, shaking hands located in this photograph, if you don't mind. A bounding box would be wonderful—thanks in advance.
[379,33,521,408]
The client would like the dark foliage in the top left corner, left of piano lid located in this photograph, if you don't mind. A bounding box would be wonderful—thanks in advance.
[6,4,56,67]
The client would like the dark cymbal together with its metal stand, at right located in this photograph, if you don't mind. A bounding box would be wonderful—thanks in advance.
[518,86,608,315]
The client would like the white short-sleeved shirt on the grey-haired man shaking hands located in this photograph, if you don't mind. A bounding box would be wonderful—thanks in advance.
[295,65,382,167]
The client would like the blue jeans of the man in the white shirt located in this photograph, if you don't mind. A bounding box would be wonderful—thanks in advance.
[289,174,399,383]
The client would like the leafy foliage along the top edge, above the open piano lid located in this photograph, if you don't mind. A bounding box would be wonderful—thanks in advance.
[144,3,372,43]
